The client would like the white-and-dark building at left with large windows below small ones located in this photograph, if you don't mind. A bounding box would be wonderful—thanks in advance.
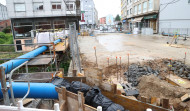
[6,0,81,51]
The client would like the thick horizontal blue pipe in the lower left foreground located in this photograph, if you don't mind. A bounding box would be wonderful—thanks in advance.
[0,82,58,99]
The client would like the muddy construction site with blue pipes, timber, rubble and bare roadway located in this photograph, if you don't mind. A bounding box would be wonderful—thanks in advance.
[0,23,190,111]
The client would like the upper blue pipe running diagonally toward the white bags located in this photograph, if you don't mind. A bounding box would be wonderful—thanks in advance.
[0,39,61,74]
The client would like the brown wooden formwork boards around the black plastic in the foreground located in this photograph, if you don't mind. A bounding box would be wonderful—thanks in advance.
[56,77,169,111]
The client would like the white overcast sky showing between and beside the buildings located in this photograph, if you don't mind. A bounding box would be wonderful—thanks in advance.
[0,0,121,18]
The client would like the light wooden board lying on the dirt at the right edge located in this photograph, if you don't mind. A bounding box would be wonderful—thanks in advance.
[166,74,190,89]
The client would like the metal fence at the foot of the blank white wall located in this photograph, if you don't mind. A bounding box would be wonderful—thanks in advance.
[160,28,190,37]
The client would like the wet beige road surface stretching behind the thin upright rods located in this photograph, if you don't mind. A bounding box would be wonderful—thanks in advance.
[79,33,190,67]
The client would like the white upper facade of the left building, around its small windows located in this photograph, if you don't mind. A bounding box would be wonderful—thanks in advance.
[6,0,76,18]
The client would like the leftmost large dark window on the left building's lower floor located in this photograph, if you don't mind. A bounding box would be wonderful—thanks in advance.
[13,22,33,38]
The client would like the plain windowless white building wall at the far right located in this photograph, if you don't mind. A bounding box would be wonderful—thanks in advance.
[159,0,190,33]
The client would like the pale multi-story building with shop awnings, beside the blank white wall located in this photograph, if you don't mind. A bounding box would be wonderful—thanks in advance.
[121,0,160,33]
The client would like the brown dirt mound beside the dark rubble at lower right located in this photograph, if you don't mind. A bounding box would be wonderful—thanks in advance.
[137,75,190,111]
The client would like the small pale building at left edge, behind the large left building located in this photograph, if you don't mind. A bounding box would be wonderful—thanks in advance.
[0,3,9,21]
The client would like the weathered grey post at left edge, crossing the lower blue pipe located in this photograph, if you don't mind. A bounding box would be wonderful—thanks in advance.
[0,66,10,106]
